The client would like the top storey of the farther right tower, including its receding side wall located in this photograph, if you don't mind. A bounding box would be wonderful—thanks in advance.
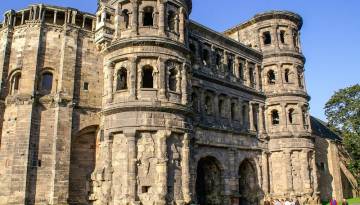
[224,11,303,55]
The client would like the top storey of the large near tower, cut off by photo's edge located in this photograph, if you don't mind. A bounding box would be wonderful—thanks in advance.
[95,0,192,45]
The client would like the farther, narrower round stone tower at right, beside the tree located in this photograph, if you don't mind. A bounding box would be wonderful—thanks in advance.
[253,11,318,203]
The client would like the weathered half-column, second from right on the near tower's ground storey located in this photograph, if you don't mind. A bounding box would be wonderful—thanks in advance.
[155,130,171,205]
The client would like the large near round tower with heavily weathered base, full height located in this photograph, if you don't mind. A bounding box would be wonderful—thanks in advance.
[91,0,192,204]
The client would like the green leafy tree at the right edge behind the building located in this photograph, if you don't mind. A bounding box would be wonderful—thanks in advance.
[325,84,360,184]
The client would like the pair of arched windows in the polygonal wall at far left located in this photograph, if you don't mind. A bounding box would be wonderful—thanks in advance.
[9,71,53,95]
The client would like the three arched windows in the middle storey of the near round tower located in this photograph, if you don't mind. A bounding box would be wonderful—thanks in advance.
[116,65,179,92]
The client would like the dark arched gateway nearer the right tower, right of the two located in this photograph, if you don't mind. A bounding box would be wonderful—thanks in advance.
[239,160,259,205]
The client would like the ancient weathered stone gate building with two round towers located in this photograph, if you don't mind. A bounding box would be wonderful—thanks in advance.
[0,0,358,205]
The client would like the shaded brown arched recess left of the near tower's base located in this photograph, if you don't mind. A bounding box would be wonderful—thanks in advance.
[68,126,97,205]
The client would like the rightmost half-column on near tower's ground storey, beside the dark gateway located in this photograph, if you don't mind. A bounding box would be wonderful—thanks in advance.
[181,133,192,204]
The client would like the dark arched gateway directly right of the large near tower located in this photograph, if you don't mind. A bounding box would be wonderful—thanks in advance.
[196,157,223,205]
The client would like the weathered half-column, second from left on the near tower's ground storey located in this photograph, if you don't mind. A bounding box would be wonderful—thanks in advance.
[124,130,137,204]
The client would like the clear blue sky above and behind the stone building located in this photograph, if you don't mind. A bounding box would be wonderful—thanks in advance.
[0,0,360,119]
